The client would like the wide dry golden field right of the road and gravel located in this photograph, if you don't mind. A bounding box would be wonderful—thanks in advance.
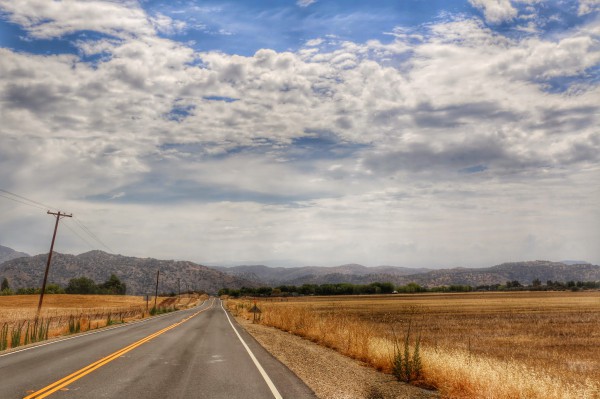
[229,292,600,399]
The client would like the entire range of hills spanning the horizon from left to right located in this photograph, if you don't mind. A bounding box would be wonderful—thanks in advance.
[0,246,600,294]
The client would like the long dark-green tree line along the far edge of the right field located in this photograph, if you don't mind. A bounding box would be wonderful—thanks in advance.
[219,279,600,297]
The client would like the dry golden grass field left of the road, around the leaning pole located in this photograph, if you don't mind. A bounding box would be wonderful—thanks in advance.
[0,294,206,350]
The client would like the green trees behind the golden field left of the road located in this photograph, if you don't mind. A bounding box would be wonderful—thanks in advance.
[0,274,127,295]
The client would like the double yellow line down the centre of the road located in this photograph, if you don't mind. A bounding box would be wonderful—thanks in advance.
[23,299,214,399]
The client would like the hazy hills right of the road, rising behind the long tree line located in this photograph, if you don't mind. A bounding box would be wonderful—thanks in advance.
[213,261,600,287]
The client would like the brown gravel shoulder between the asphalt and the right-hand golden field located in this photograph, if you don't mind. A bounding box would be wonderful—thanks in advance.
[236,317,439,399]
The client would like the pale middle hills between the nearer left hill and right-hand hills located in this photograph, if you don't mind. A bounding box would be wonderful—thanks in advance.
[213,264,431,285]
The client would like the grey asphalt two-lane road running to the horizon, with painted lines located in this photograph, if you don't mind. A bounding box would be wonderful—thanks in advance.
[0,298,315,399]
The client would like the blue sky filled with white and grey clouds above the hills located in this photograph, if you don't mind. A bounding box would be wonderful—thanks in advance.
[0,0,600,268]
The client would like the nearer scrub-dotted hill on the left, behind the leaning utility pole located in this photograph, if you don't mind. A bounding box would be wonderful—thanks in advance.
[0,251,256,294]
